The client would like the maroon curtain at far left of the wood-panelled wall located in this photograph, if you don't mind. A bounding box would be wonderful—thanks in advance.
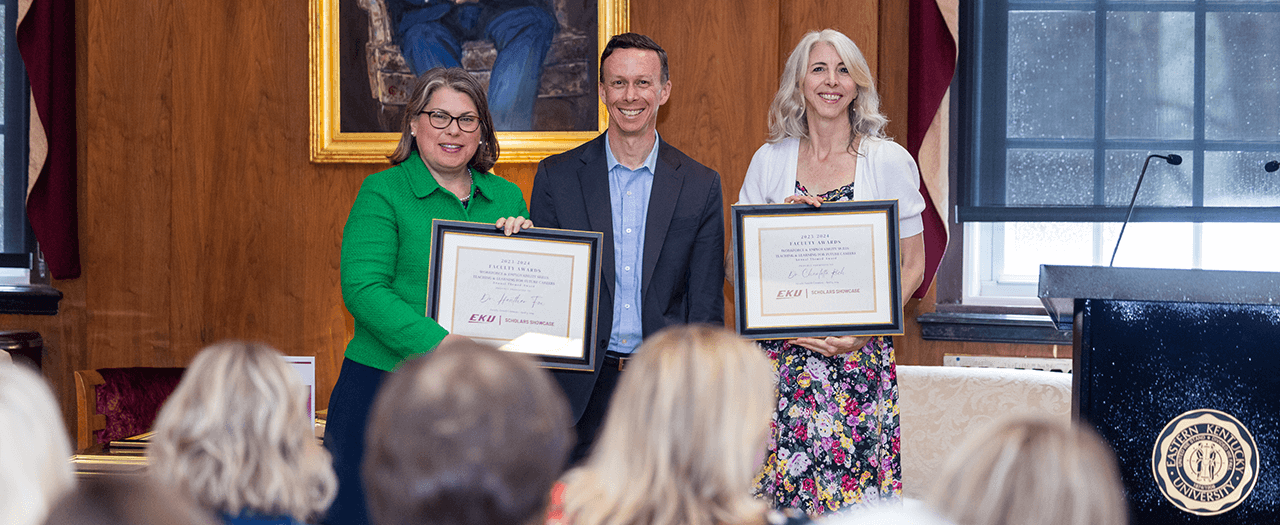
[18,0,81,279]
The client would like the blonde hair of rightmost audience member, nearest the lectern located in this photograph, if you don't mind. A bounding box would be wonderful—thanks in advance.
[928,417,1128,525]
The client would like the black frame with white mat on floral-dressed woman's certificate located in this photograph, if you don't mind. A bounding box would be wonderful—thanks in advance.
[732,200,904,339]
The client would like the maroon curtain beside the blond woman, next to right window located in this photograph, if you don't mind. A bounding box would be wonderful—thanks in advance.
[906,0,956,297]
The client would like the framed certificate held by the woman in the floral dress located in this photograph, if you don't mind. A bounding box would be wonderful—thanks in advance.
[733,201,902,339]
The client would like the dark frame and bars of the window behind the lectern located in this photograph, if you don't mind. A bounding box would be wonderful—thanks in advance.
[951,0,1280,223]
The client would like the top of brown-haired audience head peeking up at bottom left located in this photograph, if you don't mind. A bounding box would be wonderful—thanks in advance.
[45,475,218,525]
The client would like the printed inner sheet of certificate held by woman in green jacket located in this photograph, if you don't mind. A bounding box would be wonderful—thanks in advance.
[448,246,581,353]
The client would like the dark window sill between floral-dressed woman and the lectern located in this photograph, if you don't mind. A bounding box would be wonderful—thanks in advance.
[916,305,1073,346]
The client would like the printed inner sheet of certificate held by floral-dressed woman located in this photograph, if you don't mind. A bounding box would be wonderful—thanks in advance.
[759,224,876,316]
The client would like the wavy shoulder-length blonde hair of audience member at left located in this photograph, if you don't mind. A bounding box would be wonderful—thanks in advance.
[147,342,337,521]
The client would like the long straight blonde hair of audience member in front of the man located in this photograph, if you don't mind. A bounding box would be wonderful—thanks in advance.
[564,325,776,525]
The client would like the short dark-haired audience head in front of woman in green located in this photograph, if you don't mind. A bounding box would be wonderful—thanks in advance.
[364,342,573,525]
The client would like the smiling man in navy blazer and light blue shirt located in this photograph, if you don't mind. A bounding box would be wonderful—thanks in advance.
[530,33,724,462]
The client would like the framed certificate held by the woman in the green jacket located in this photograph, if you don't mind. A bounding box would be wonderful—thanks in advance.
[426,219,604,370]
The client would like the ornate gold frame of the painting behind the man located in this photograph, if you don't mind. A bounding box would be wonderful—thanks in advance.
[308,0,630,164]
